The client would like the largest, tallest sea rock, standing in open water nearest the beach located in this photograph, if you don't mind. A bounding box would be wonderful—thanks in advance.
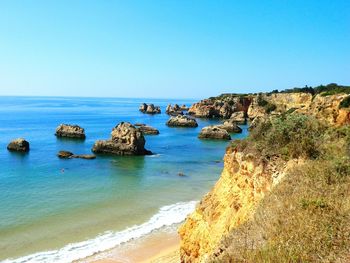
[92,122,152,155]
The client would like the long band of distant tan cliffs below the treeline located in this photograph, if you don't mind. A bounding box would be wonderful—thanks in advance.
[188,84,350,125]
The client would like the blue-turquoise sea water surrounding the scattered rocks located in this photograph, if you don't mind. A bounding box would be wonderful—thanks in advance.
[0,97,247,262]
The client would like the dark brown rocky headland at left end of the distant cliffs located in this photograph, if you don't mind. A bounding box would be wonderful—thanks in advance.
[188,94,252,119]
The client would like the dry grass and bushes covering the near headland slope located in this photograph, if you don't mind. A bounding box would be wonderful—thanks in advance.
[210,113,350,262]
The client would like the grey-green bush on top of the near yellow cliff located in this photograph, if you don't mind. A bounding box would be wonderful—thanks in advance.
[232,114,326,160]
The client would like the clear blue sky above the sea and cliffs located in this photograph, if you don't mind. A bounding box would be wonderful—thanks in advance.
[0,0,350,98]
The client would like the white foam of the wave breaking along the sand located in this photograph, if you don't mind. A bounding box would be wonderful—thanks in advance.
[3,201,197,263]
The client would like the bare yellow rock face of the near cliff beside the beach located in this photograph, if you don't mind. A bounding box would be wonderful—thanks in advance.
[179,148,292,262]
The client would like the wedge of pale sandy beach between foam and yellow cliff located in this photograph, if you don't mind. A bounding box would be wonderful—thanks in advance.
[77,230,180,263]
